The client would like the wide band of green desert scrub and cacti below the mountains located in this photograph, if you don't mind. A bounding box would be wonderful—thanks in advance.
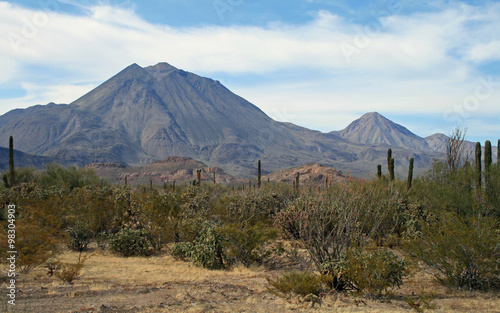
[0,136,500,311]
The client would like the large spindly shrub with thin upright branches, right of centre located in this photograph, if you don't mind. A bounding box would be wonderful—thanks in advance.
[275,181,399,270]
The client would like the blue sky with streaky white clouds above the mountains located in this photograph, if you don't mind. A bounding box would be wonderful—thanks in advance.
[0,0,500,143]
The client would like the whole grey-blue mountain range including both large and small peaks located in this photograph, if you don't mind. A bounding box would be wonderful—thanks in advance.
[0,63,441,177]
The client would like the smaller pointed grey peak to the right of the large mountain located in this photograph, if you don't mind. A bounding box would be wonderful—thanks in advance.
[339,112,429,151]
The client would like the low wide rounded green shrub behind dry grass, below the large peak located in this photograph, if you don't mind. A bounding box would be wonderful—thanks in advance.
[109,228,153,257]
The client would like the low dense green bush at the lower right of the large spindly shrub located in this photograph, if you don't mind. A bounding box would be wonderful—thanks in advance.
[322,249,407,296]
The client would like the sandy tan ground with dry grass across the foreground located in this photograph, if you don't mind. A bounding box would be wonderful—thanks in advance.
[0,252,500,313]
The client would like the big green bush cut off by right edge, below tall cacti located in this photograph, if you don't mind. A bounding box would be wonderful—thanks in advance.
[405,214,500,290]
